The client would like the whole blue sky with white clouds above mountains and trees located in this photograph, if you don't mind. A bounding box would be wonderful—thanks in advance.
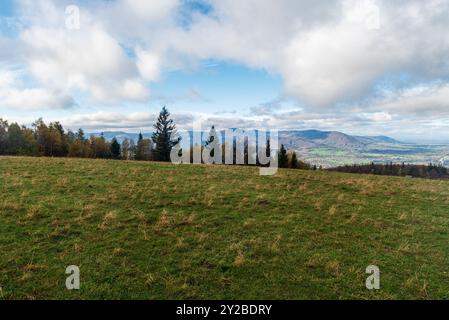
[0,0,449,142]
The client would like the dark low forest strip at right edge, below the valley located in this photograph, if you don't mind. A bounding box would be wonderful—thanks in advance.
[328,162,449,179]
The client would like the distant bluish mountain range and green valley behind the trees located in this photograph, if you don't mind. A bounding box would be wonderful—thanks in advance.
[89,130,449,167]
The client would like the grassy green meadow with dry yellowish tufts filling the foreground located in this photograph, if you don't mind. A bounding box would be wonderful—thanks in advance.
[0,158,449,299]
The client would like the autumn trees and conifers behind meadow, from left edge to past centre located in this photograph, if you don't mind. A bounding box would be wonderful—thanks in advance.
[0,107,316,169]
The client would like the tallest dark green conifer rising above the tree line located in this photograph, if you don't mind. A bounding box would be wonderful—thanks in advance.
[152,107,180,161]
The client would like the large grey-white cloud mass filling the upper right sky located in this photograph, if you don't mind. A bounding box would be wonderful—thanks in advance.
[166,0,449,107]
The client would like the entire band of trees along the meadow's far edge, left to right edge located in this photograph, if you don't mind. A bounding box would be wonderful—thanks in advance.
[4,107,449,179]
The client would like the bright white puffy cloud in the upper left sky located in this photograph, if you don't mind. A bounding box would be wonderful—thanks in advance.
[22,25,147,103]
